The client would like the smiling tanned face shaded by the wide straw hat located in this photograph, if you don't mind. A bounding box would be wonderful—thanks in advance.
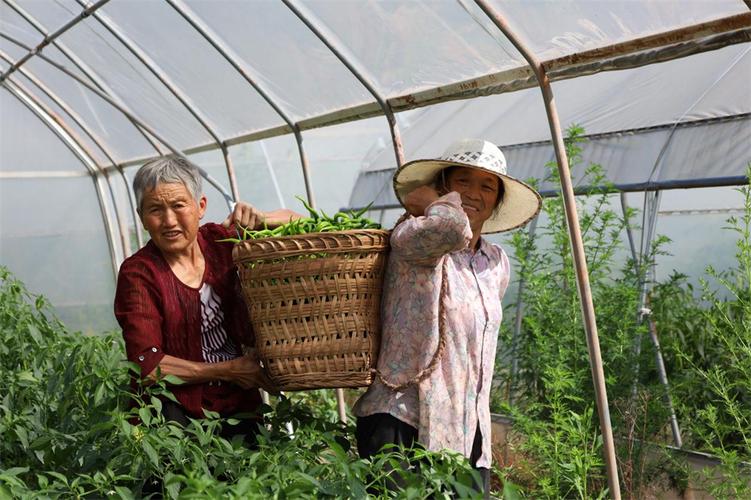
[445,167,501,234]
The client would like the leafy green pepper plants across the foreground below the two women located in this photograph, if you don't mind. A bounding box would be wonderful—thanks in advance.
[0,267,510,499]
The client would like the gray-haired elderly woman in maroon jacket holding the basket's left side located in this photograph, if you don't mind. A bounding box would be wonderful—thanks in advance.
[115,157,300,436]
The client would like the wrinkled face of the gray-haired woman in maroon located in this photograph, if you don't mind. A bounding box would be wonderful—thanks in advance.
[141,183,206,254]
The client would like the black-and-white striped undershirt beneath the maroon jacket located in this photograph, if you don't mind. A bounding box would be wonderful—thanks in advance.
[199,283,240,363]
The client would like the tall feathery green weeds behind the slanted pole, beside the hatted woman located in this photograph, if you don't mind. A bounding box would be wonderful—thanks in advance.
[495,126,684,498]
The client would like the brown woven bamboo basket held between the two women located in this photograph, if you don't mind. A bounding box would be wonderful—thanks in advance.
[232,229,389,391]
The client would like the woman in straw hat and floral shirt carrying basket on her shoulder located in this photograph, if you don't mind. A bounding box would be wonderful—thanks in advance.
[354,139,541,496]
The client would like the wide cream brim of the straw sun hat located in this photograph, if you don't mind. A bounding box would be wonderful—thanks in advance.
[393,160,542,234]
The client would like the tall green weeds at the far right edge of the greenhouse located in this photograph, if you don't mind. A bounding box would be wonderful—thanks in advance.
[654,169,751,498]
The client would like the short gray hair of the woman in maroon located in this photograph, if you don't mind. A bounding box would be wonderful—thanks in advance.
[133,156,203,215]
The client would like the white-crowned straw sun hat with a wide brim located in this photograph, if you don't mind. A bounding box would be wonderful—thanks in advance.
[394,139,542,233]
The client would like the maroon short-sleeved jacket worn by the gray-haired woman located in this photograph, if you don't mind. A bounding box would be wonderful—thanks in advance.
[115,223,261,418]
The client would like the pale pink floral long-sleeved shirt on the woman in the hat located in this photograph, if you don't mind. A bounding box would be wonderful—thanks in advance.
[354,192,510,467]
